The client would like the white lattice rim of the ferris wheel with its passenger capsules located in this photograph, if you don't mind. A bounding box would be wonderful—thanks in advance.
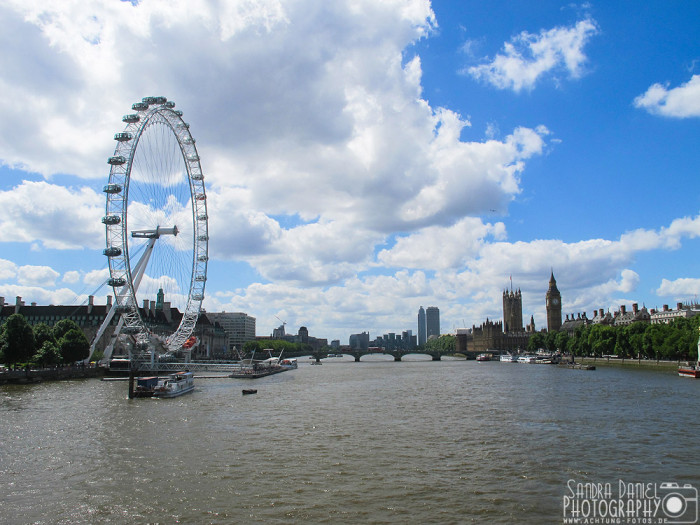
[103,97,209,350]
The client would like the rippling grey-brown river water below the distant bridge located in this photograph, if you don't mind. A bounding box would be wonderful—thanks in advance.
[0,357,700,524]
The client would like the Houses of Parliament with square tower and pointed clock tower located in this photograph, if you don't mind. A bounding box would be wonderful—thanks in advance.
[456,272,562,353]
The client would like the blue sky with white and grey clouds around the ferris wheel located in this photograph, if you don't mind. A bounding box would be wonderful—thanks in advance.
[0,0,700,343]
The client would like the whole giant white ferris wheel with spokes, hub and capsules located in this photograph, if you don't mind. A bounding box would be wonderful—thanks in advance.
[95,97,209,358]
